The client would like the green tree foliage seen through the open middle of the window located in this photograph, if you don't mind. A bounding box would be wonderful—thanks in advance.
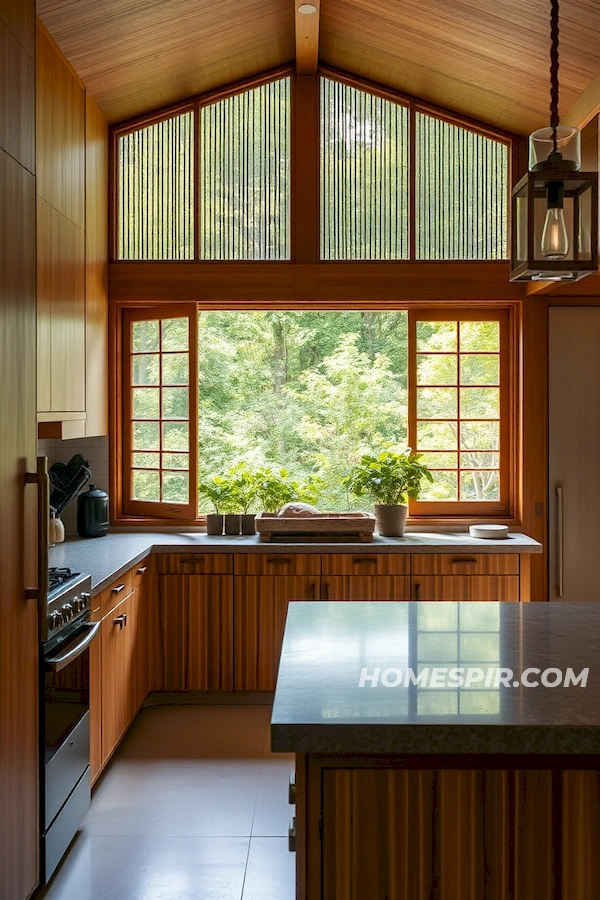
[198,312,408,513]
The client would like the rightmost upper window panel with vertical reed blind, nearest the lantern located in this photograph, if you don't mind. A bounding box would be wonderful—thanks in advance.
[415,112,508,259]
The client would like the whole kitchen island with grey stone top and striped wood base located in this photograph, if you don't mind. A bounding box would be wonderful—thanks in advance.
[271,602,600,900]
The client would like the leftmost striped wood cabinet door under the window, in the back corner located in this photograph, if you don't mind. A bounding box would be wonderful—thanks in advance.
[158,575,233,691]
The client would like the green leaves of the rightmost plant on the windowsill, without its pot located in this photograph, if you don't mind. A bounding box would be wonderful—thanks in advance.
[342,447,433,506]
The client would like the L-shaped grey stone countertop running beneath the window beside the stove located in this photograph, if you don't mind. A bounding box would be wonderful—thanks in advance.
[48,531,542,594]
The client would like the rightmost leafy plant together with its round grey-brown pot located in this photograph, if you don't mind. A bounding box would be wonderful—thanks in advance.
[343,447,433,537]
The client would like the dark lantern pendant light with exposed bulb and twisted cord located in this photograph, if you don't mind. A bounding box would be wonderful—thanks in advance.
[510,0,598,281]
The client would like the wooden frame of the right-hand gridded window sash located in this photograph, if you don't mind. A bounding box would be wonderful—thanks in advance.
[408,304,519,522]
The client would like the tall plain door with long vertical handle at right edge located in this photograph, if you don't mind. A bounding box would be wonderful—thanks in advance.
[548,306,600,602]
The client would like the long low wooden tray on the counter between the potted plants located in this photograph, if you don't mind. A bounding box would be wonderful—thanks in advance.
[255,513,375,542]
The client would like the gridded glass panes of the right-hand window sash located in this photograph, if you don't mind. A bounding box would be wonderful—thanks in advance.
[416,320,500,501]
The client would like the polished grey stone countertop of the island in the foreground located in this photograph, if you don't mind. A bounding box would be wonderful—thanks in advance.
[271,602,600,755]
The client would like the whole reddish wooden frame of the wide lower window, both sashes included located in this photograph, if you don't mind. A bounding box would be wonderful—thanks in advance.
[110,300,522,527]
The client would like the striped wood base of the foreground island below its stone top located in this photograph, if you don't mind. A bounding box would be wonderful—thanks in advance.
[296,754,600,900]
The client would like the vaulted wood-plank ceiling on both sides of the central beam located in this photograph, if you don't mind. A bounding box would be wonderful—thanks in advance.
[37,0,600,134]
